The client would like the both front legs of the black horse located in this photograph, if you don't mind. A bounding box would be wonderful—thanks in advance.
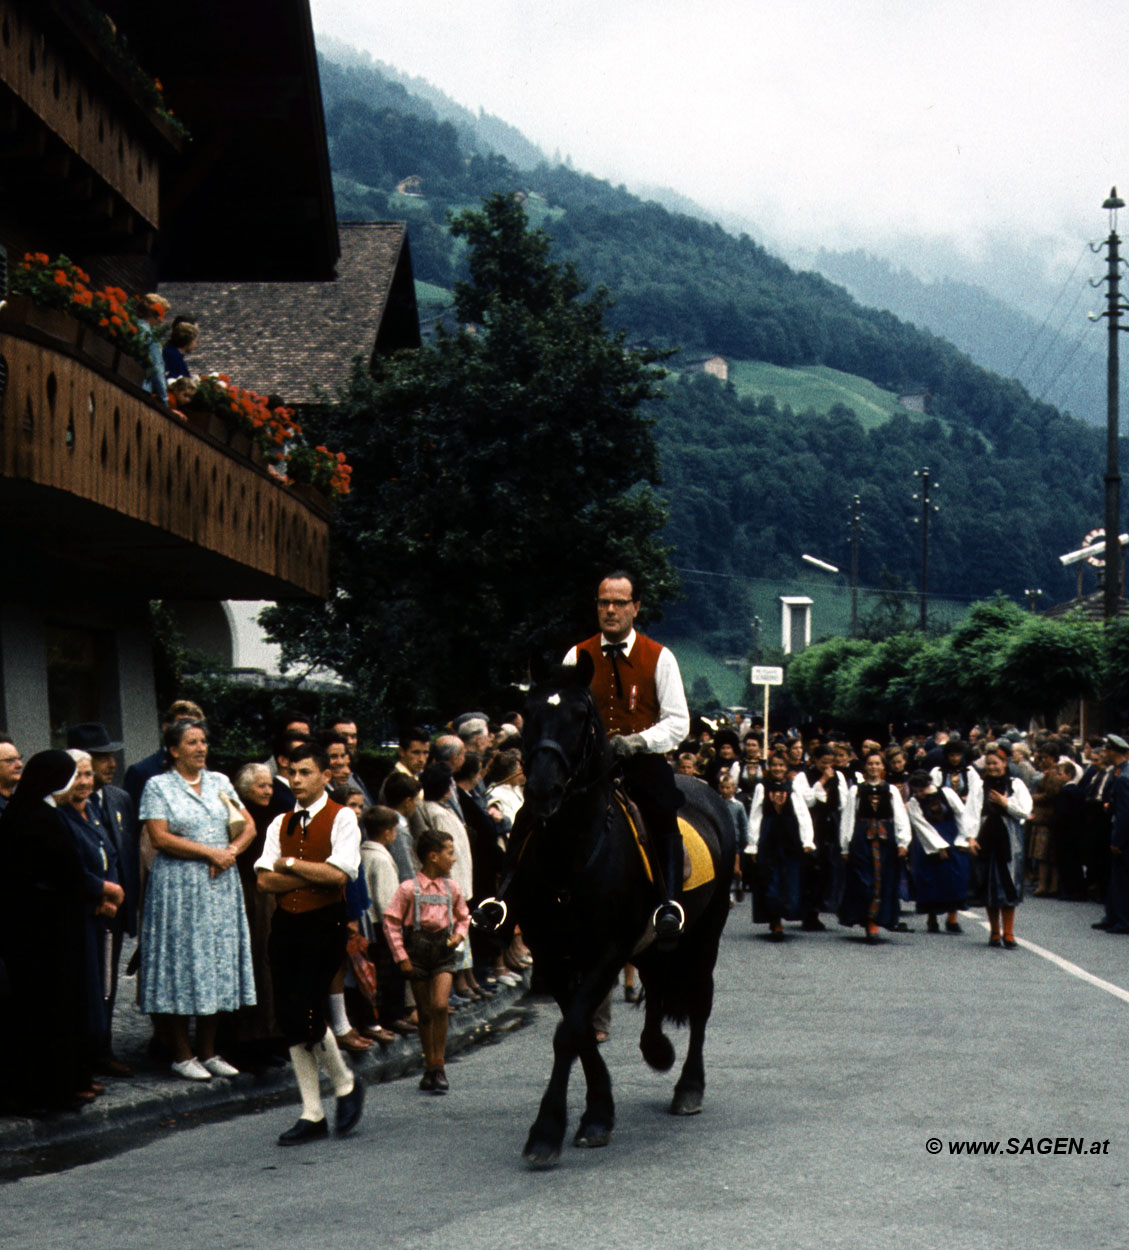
[523,961,619,1168]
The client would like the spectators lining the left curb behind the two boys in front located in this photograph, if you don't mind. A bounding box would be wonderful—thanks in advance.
[0,700,531,1113]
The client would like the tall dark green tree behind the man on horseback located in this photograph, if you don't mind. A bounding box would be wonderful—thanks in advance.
[264,195,676,715]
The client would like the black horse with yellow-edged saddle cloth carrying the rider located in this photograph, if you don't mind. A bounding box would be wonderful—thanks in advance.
[492,653,734,1168]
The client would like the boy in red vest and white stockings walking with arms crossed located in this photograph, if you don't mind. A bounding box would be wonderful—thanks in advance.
[255,744,365,1146]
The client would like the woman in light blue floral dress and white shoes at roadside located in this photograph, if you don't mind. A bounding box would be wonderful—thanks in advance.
[140,720,255,1080]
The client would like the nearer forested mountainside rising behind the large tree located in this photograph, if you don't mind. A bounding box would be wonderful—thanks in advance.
[321,44,1104,649]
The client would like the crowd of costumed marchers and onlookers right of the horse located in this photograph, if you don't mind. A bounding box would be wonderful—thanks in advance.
[671,716,1129,946]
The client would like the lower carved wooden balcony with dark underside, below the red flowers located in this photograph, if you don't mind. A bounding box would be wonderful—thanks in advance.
[0,328,329,599]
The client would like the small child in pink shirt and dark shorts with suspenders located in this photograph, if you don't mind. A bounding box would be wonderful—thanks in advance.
[384,829,470,1094]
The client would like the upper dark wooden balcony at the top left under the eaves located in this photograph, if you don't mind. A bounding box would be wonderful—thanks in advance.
[0,0,178,251]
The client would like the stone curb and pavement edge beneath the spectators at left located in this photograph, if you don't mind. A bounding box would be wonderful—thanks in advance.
[0,973,530,1181]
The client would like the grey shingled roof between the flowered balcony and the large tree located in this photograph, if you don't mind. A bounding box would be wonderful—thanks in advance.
[160,221,420,404]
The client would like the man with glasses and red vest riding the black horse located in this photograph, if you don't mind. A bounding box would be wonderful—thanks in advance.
[565,570,690,946]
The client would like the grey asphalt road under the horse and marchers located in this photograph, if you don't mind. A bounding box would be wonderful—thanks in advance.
[8,900,1129,1250]
